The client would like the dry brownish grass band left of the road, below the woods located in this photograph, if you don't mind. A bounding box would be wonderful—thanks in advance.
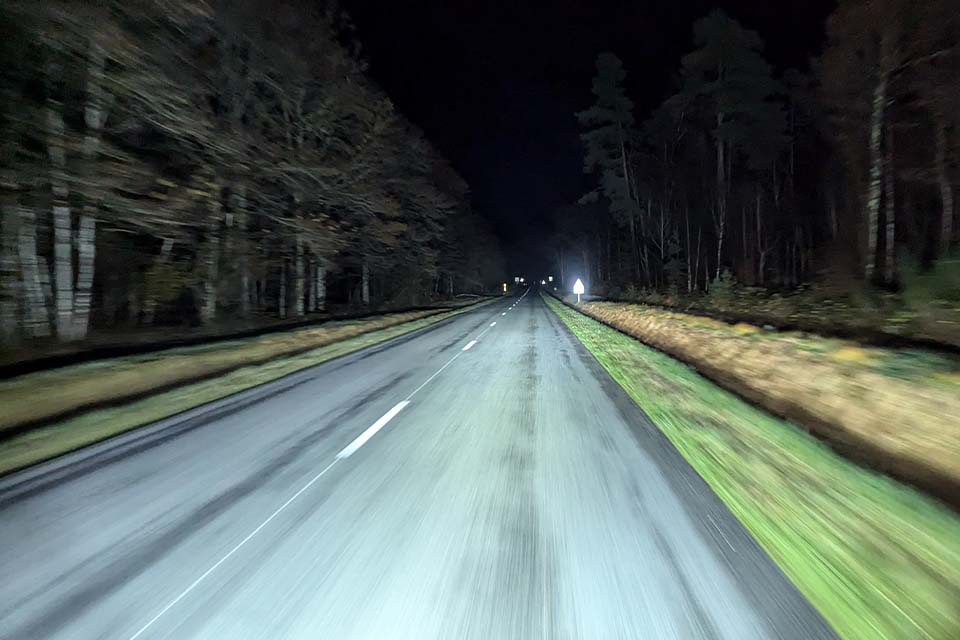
[0,310,443,437]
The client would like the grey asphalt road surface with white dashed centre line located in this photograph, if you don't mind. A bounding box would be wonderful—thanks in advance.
[0,291,833,640]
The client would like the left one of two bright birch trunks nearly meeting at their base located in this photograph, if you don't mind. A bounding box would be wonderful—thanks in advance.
[46,100,75,340]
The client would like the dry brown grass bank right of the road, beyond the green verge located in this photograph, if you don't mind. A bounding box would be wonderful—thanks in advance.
[577,302,960,505]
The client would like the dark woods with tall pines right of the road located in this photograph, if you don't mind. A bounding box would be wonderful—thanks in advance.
[554,0,960,302]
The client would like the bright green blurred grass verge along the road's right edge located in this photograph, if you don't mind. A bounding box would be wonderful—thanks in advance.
[546,297,960,640]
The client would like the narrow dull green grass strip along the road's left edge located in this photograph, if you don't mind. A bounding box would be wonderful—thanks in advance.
[0,302,486,475]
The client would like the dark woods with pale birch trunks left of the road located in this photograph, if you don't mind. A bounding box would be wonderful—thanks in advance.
[0,0,503,344]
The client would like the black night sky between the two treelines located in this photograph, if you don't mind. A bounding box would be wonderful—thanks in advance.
[343,0,835,272]
